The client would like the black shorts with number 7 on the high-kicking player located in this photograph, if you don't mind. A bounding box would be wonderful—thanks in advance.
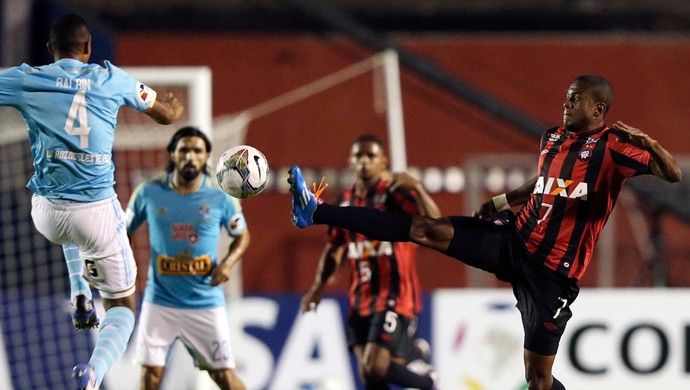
[446,214,580,355]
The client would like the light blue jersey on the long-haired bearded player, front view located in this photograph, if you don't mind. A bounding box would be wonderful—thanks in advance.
[127,174,247,309]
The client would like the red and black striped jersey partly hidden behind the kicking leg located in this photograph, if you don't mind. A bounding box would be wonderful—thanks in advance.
[328,180,422,317]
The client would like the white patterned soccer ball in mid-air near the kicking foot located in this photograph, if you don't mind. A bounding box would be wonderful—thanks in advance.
[216,145,269,198]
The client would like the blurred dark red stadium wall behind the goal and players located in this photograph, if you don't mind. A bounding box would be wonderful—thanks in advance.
[114,33,690,292]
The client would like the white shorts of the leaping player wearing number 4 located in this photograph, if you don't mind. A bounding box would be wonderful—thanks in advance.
[31,195,137,299]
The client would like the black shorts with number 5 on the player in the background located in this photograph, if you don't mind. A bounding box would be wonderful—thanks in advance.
[347,310,417,359]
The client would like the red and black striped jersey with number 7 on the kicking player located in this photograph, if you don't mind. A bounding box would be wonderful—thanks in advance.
[516,126,650,280]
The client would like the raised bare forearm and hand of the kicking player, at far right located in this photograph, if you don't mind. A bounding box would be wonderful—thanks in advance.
[613,121,683,183]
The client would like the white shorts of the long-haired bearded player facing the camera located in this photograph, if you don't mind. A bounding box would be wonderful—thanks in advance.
[136,301,235,370]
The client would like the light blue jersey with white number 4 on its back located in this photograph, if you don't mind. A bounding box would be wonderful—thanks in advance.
[0,59,156,201]
